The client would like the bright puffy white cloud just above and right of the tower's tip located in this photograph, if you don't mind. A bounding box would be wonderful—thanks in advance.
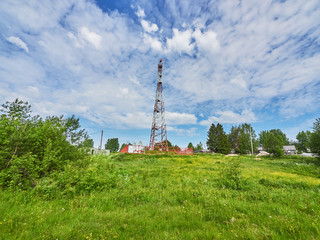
[167,28,194,54]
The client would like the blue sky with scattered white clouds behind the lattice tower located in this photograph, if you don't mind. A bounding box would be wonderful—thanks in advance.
[0,0,320,147]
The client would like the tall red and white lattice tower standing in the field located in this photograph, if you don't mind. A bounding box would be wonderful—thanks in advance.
[149,59,168,151]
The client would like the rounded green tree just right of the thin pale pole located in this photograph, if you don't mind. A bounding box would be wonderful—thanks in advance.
[259,129,289,157]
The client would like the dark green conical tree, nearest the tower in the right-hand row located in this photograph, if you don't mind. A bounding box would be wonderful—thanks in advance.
[207,123,231,154]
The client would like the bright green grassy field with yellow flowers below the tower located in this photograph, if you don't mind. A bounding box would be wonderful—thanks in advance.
[0,154,320,239]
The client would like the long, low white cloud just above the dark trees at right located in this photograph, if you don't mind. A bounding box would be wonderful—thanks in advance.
[200,110,257,126]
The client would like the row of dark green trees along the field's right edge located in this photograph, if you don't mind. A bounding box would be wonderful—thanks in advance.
[207,121,320,157]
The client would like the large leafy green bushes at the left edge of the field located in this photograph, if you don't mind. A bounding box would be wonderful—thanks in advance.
[0,99,87,189]
